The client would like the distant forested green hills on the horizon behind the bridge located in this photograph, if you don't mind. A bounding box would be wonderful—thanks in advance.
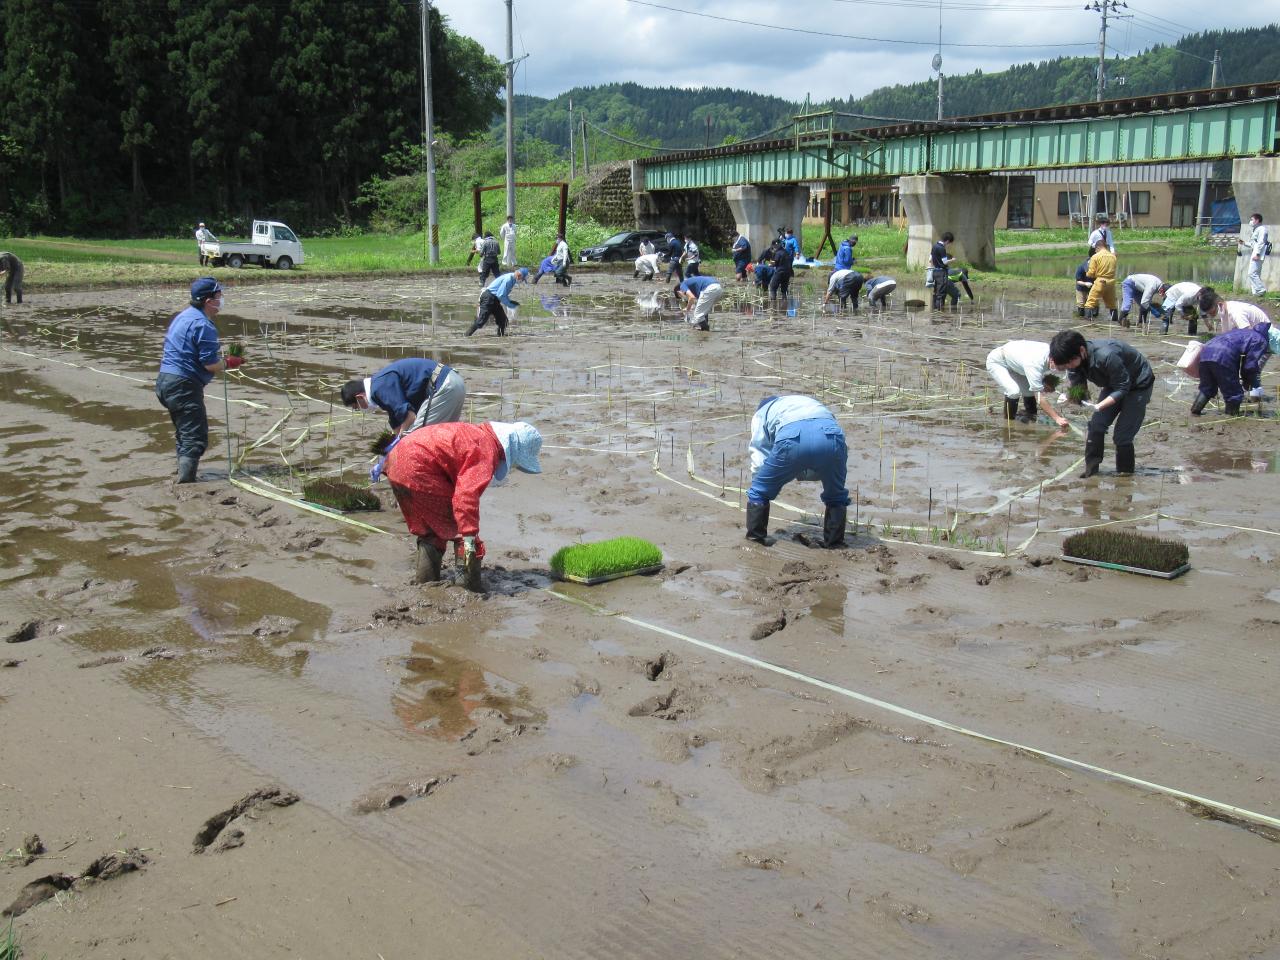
[509,24,1280,147]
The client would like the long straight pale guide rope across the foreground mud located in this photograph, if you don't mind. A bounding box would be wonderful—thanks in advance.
[545,588,1280,840]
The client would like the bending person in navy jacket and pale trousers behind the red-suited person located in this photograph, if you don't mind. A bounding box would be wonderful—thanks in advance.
[342,357,467,436]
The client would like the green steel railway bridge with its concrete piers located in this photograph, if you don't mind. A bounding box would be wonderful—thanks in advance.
[631,82,1280,280]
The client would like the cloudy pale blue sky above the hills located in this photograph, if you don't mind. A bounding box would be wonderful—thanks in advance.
[433,0,1270,100]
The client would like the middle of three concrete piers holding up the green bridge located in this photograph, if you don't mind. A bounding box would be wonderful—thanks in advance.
[897,174,1009,270]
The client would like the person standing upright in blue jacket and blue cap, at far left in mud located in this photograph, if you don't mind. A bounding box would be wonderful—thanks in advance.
[156,276,243,484]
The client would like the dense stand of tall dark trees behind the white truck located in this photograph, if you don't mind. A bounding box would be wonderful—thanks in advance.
[0,0,504,236]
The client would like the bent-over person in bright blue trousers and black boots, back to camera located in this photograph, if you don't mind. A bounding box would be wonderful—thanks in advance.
[746,396,849,547]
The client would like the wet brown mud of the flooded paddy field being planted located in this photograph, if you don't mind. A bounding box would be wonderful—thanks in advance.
[0,274,1280,960]
